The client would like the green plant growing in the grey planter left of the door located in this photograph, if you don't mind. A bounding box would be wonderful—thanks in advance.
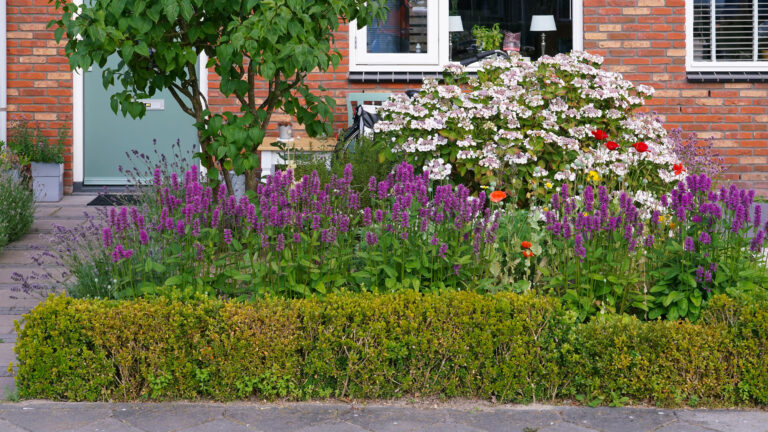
[7,120,66,165]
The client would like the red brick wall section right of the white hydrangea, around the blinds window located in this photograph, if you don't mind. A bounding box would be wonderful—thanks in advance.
[584,0,768,193]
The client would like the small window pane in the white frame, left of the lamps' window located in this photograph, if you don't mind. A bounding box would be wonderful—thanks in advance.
[366,0,429,54]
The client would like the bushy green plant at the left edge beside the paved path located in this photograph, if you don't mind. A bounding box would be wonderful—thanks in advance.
[0,170,35,248]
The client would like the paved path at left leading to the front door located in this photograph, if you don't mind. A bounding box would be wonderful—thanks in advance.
[0,194,96,398]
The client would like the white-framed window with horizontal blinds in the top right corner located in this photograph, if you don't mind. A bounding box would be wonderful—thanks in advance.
[686,0,768,71]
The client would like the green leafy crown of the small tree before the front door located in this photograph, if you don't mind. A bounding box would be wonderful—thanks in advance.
[50,0,385,189]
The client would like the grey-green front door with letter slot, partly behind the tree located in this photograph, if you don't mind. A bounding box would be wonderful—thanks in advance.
[83,56,199,185]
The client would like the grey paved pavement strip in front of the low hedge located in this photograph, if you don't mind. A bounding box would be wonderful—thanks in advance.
[0,401,768,432]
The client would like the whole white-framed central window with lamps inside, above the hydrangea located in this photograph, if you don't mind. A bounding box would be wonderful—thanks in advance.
[350,0,581,72]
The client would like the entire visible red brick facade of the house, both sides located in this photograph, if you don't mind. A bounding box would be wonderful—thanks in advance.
[7,0,768,191]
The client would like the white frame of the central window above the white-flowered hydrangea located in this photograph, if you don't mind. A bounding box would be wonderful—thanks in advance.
[349,0,584,72]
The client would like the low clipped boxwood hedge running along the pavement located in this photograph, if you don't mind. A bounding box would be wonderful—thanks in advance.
[16,292,768,406]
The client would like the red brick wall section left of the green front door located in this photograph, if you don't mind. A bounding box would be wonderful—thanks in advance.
[6,0,72,193]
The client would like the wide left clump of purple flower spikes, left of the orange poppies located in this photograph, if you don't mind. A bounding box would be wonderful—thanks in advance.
[24,163,498,298]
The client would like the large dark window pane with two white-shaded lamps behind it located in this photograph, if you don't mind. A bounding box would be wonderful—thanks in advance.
[450,0,573,61]
